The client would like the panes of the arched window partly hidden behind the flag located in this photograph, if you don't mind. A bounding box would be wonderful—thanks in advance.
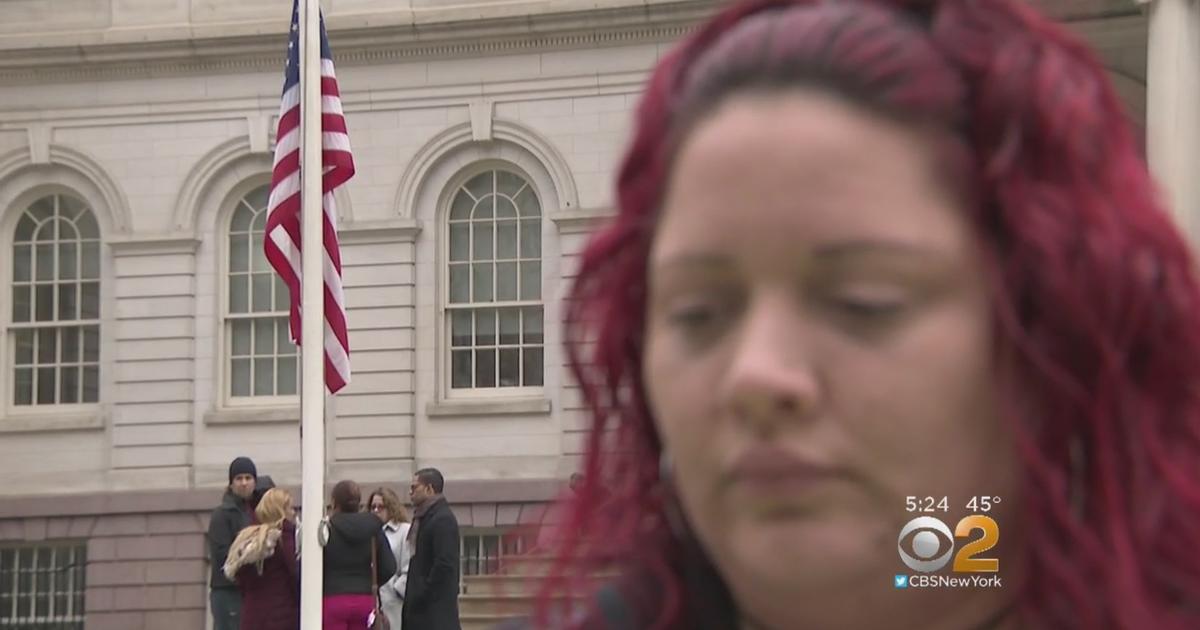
[224,186,298,402]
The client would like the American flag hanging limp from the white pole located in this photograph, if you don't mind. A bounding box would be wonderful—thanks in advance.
[263,0,354,394]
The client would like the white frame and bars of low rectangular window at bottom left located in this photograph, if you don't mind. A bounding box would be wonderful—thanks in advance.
[0,541,88,630]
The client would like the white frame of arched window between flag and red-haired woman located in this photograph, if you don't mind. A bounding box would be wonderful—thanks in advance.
[437,160,550,402]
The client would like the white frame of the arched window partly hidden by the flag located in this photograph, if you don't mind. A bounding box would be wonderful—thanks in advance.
[214,181,300,410]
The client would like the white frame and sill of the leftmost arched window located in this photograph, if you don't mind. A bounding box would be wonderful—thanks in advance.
[0,193,102,417]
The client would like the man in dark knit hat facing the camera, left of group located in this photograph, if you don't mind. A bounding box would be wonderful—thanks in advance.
[208,457,258,630]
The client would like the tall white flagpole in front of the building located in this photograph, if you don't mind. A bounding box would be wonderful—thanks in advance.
[300,0,325,630]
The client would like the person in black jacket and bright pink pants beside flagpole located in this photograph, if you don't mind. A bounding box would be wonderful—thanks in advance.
[322,481,396,630]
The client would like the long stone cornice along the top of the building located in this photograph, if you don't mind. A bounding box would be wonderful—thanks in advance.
[0,0,716,85]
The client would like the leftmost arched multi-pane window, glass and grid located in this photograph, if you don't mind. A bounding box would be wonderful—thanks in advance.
[8,194,101,407]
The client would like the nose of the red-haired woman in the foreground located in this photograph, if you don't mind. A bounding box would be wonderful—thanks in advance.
[721,299,820,434]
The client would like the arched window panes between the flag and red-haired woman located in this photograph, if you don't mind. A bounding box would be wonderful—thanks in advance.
[444,169,545,395]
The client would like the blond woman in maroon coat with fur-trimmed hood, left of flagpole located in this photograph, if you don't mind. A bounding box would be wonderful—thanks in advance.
[224,488,300,630]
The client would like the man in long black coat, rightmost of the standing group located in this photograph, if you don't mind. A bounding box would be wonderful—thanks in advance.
[403,468,462,630]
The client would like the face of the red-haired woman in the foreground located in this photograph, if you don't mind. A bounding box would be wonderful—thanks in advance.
[643,90,1016,629]
